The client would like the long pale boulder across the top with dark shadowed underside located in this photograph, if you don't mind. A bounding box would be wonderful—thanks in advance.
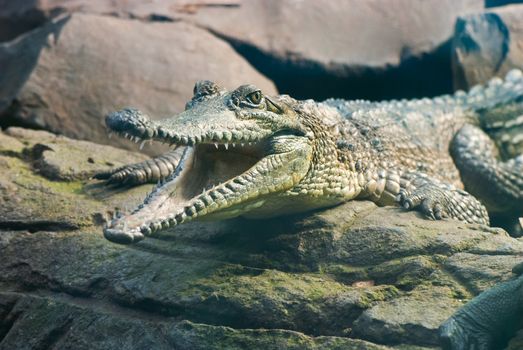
[0,0,484,99]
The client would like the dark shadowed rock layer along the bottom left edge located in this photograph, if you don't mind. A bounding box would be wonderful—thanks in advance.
[0,293,387,350]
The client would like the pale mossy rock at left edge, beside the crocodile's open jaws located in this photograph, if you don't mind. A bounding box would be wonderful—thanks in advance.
[0,128,151,232]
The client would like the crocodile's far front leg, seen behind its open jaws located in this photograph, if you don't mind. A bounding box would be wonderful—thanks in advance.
[94,147,184,186]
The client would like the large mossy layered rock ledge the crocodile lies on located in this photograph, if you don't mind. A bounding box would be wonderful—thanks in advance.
[0,128,523,350]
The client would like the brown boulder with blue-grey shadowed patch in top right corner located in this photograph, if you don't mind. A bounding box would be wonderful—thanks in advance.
[452,5,523,89]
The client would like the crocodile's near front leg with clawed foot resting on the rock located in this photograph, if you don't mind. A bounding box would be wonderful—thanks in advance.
[366,171,489,225]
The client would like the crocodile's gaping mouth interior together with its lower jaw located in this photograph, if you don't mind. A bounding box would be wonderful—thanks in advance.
[104,136,270,243]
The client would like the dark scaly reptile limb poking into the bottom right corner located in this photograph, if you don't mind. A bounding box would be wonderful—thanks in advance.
[440,276,523,350]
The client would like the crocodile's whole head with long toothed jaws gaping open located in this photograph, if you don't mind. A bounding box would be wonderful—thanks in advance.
[104,81,322,243]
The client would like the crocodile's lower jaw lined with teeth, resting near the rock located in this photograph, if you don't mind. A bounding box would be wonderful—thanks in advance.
[105,140,308,243]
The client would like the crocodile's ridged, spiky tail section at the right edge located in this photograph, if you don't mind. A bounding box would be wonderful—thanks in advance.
[455,69,523,158]
